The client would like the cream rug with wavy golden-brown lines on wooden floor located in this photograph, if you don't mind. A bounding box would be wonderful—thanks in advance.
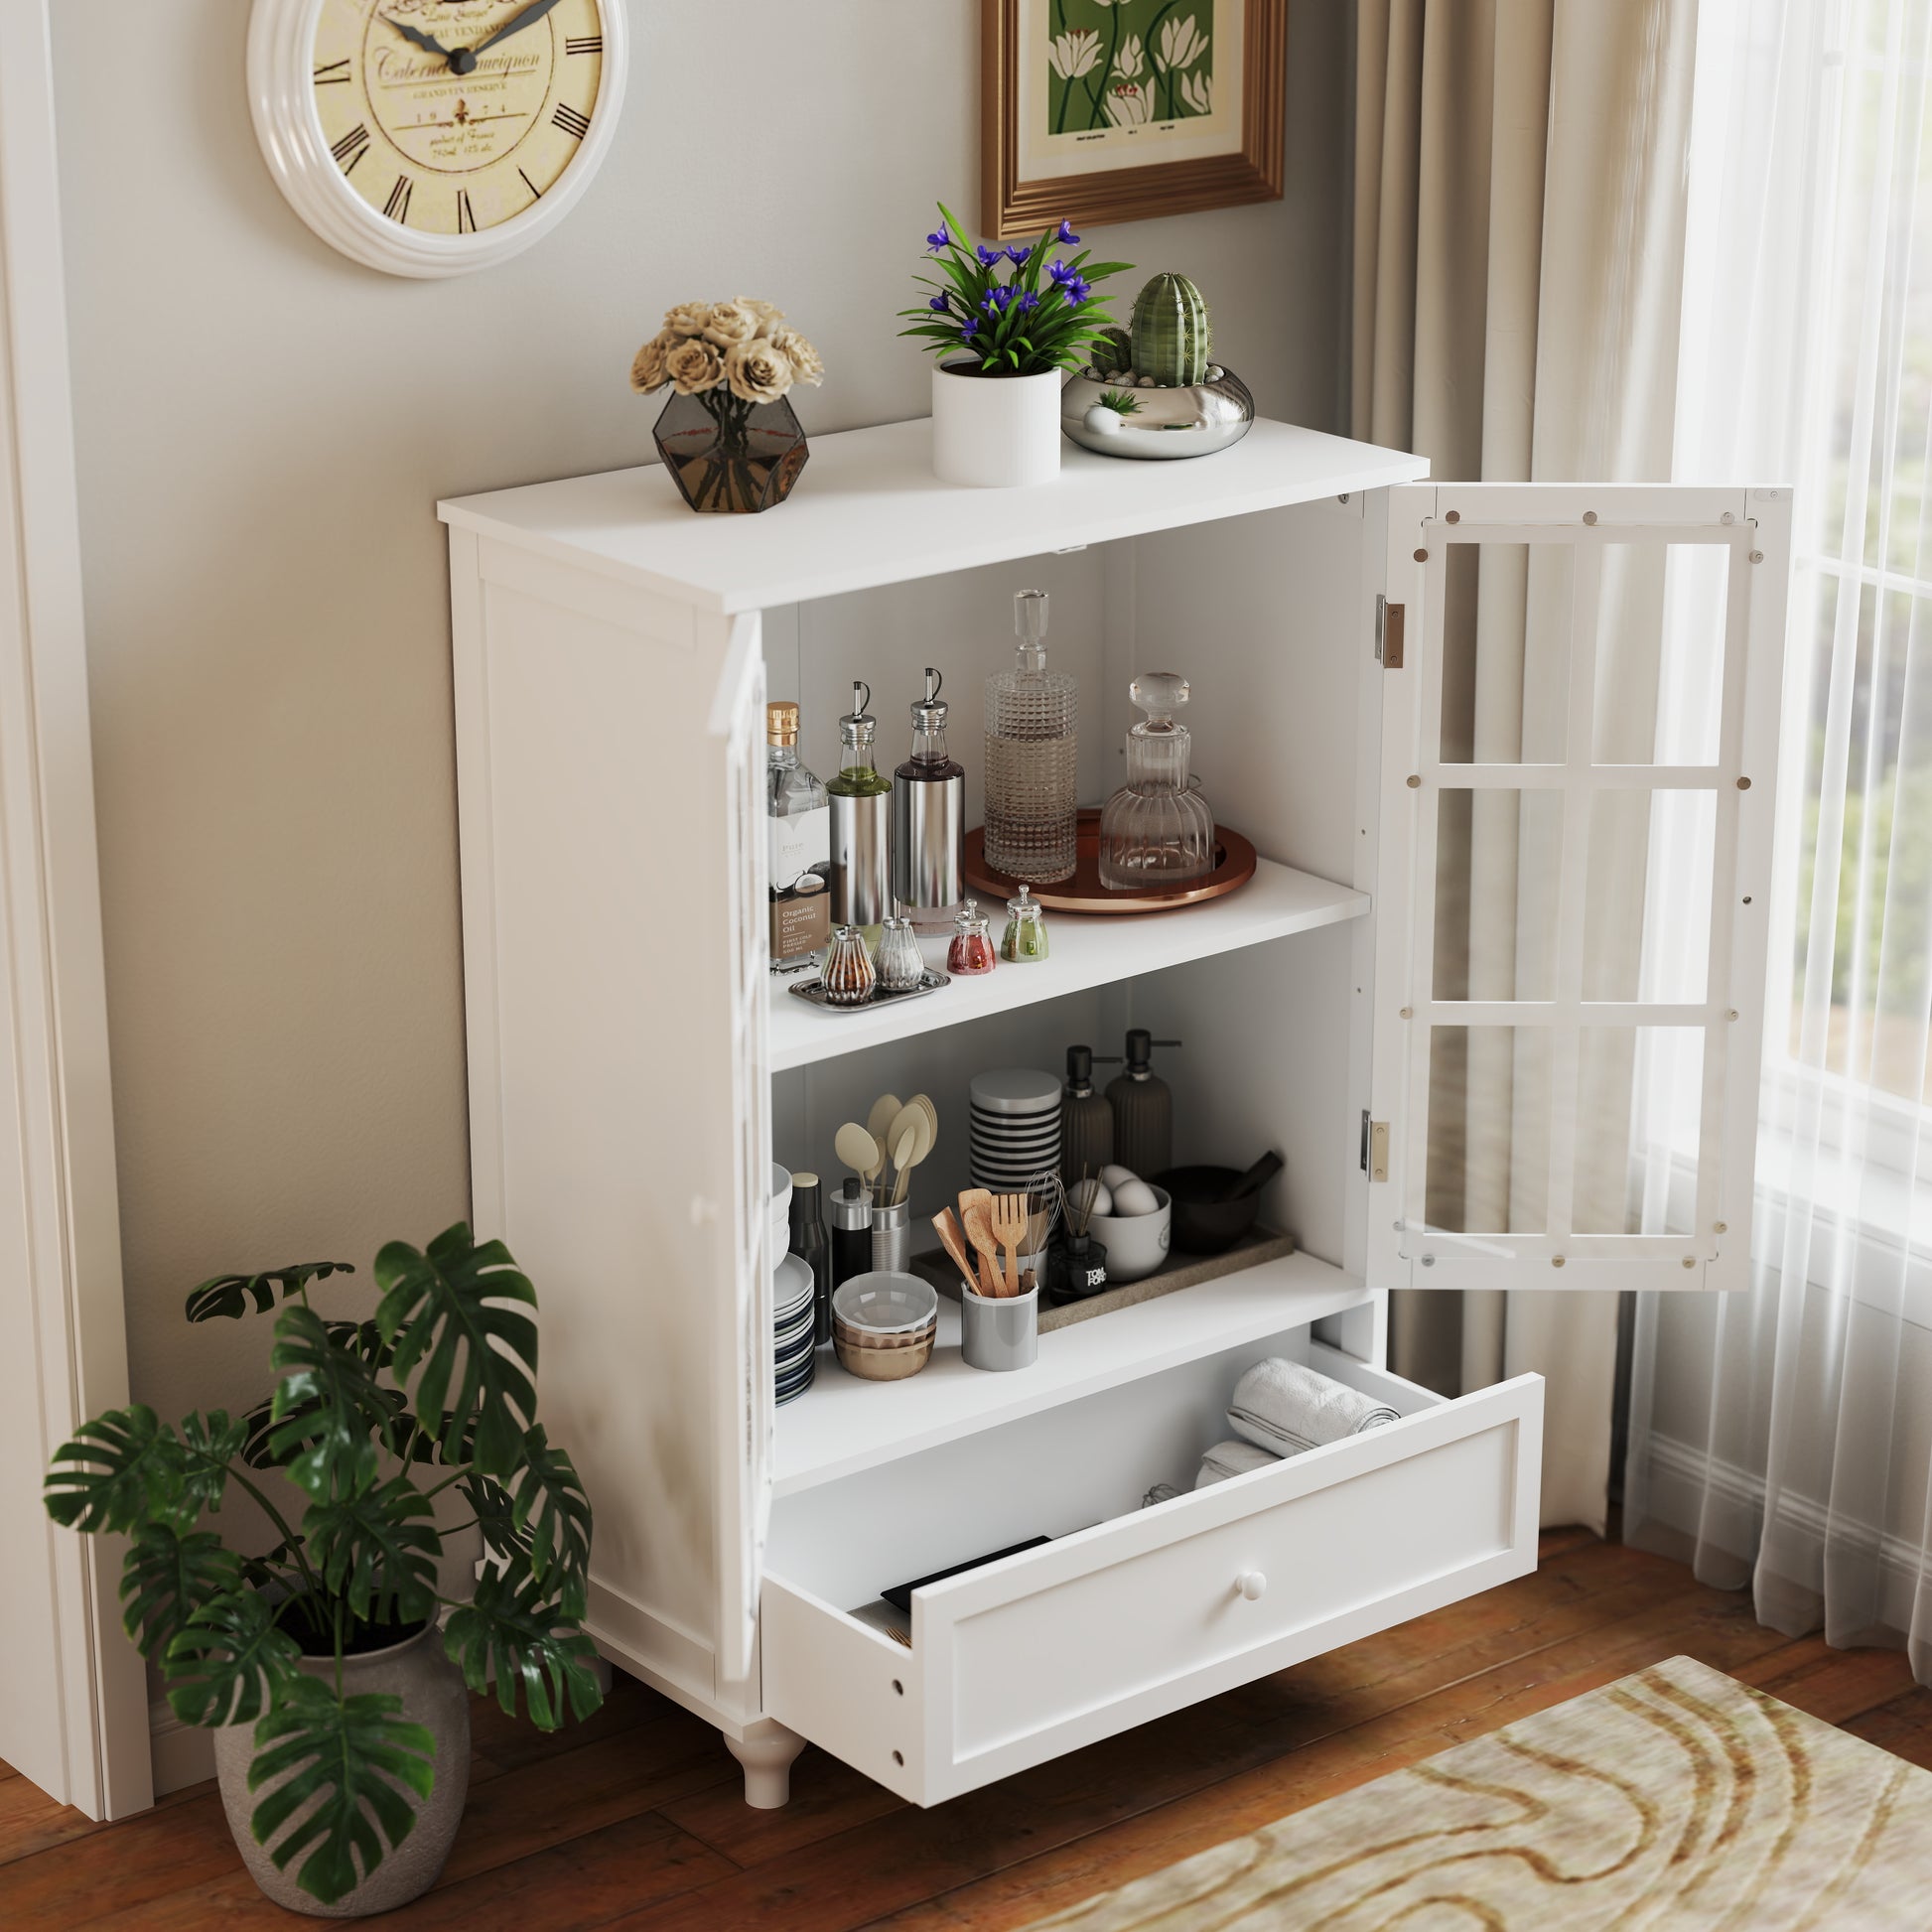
[1030,1658,1932,1932]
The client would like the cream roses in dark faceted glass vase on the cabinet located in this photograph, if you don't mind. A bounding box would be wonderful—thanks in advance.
[629,296,825,510]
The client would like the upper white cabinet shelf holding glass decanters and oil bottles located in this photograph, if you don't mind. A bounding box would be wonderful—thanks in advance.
[770,860,1370,1072]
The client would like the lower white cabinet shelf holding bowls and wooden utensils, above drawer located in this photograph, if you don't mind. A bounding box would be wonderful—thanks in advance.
[772,1254,1368,1497]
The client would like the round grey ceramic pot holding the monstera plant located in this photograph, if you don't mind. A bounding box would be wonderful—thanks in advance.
[214,1623,470,1918]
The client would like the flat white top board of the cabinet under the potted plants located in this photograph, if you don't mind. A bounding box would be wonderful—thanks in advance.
[437,417,1428,617]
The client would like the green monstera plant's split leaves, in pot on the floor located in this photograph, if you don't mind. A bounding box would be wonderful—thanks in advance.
[47,1223,601,1905]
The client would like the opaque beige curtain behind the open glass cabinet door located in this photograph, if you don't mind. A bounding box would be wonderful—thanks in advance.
[1350,0,1697,1532]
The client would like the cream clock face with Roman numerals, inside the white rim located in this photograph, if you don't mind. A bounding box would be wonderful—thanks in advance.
[313,0,615,235]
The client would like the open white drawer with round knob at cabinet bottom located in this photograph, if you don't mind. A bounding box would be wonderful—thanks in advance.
[759,1329,1544,1805]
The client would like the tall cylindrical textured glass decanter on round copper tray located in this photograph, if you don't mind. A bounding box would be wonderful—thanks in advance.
[985,591,1080,885]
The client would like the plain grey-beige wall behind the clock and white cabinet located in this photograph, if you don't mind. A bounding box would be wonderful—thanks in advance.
[54,0,1346,1416]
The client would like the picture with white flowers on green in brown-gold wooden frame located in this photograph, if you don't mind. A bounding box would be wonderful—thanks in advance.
[980,0,1289,239]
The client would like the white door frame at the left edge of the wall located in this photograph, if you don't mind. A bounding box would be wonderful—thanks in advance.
[0,0,153,1818]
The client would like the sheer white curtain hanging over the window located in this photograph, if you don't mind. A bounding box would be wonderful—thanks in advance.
[1625,0,1932,1681]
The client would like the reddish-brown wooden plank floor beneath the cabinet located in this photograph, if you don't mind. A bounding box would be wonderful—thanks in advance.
[0,1530,1932,1932]
